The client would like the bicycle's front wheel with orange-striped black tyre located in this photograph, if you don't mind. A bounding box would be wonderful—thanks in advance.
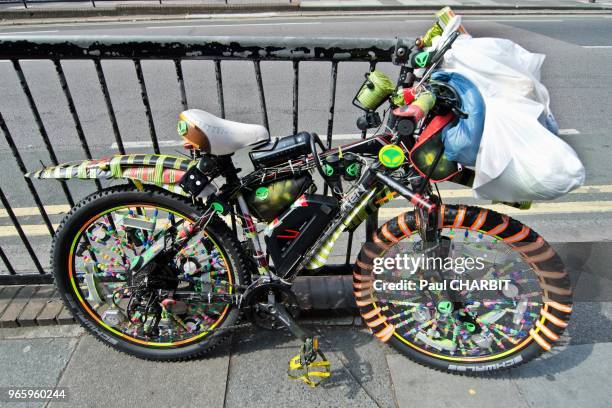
[353,205,572,373]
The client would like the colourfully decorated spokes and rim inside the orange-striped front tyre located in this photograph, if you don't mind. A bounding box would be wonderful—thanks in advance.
[372,228,543,362]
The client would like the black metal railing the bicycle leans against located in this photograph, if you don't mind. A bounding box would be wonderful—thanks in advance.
[0,36,414,284]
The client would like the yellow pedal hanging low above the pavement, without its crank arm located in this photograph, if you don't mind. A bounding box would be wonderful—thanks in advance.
[287,338,331,388]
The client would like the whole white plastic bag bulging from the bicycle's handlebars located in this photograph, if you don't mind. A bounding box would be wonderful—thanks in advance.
[443,36,585,201]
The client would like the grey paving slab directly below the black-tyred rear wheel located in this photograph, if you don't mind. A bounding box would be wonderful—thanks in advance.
[49,336,229,408]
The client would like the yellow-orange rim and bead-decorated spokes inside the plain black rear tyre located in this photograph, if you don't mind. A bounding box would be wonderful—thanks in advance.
[68,203,234,347]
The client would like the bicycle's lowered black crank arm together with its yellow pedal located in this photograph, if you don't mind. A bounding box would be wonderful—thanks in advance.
[268,293,331,388]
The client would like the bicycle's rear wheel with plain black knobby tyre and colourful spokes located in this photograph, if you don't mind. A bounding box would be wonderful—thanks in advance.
[52,186,247,360]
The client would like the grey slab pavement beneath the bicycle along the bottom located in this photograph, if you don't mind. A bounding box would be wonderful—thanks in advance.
[0,303,612,408]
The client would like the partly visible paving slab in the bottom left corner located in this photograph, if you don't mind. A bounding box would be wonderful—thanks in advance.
[0,338,78,407]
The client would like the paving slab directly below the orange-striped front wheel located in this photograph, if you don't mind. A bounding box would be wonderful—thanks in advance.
[387,354,529,408]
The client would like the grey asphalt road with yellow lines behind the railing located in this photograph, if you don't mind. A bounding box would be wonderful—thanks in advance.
[0,15,612,273]
